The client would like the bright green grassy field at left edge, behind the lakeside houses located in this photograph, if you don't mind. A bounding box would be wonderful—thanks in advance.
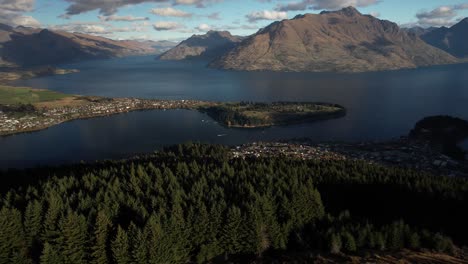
[0,85,70,105]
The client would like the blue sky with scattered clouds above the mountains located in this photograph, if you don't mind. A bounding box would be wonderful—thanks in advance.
[0,0,468,40]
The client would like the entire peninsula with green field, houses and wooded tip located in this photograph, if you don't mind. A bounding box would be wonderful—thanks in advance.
[0,85,346,136]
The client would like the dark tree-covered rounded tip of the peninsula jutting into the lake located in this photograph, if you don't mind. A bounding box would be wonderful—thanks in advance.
[200,102,346,128]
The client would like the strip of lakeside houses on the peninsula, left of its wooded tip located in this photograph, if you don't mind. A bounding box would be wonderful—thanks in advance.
[0,98,209,136]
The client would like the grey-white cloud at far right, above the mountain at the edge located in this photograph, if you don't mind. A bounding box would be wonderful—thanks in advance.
[415,4,468,27]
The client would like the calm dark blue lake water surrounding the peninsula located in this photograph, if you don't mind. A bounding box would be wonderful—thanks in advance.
[0,57,468,168]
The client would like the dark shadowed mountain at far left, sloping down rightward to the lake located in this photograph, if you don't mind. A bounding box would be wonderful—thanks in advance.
[0,25,157,67]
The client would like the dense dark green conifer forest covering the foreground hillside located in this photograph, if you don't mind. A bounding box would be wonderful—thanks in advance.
[0,144,468,264]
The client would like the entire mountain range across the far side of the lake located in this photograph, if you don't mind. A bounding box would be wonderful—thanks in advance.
[0,7,468,72]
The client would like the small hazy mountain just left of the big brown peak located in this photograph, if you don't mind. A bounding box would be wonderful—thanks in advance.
[159,31,242,60]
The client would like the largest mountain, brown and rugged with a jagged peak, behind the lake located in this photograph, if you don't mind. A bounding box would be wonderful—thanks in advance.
[210,7,457,72]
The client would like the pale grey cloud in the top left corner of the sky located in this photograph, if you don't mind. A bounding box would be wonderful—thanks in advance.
[0,0,41,27]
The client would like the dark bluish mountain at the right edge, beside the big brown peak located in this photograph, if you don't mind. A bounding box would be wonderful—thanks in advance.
[421,18,468,58]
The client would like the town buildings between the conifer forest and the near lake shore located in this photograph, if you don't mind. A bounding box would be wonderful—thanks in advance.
[232,138,468,177]
